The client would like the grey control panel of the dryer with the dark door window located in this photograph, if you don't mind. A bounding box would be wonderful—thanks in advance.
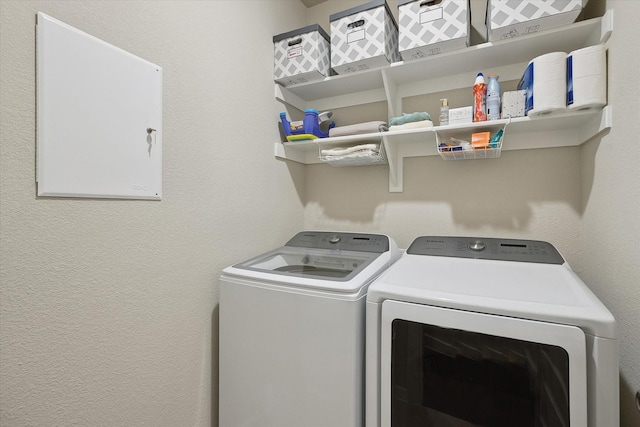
[407,236,564,264]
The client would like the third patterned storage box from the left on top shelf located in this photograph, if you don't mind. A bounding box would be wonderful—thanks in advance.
[398,0,471,61]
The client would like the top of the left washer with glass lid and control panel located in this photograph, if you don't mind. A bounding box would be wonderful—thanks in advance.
[224,231,399,292]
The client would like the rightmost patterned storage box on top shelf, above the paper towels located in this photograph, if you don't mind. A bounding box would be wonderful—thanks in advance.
[486,0,588,41]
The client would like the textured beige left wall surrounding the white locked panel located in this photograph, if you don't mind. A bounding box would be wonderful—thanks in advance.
[0,0,305,427]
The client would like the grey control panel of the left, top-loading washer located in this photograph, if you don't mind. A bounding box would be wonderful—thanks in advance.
[286,231,389,253]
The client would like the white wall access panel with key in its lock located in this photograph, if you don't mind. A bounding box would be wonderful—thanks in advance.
[36,12,162,200]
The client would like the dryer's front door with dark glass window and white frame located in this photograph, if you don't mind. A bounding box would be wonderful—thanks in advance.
[380,300,587,427]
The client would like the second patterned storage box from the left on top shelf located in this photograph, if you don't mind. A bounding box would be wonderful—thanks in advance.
[329,0,400,74]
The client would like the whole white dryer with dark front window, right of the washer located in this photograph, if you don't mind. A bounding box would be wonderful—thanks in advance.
[366,236,619,427]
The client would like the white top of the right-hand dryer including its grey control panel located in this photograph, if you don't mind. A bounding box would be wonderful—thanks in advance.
[367,236,617,338]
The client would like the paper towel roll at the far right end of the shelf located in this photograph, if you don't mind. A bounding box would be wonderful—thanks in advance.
[567,44,607,110]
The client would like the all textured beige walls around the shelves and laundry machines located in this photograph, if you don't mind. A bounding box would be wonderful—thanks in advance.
[0,0,640,427]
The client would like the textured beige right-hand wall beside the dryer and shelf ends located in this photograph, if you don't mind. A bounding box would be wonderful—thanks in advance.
[581,0,640,427]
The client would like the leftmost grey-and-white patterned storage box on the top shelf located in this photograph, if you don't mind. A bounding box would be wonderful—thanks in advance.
[273,24,331,86]
